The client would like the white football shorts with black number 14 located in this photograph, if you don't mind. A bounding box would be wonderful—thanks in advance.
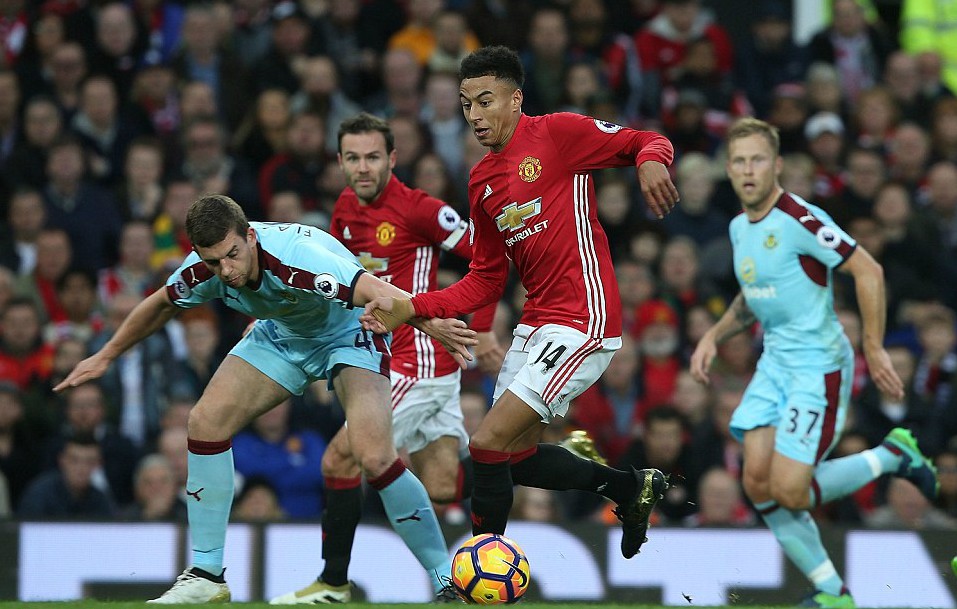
[493,324,621,423]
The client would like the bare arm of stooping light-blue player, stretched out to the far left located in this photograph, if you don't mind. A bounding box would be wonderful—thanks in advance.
[53,288,179,392]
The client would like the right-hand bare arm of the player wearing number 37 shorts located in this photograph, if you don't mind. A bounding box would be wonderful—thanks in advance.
[839,246,904,399]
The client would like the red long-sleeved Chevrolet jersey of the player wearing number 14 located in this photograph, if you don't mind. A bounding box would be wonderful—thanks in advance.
[412,113,674,338]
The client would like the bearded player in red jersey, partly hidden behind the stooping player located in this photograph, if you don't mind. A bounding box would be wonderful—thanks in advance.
[272,113,503,604]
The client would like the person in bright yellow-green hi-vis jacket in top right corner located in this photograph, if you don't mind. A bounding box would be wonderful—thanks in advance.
[900,0,957,91]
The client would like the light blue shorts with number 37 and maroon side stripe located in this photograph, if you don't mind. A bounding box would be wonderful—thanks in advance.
[730,356,854,465]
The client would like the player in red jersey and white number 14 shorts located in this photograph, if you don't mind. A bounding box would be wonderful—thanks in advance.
[363,46,678,558]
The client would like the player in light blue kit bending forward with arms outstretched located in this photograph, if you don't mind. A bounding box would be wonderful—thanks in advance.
[56,195,477,604]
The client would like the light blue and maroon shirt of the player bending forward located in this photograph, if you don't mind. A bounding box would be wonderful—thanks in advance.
[166,222,365,338]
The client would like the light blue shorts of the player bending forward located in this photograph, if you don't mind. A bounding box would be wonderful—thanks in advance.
[229,319,392,395]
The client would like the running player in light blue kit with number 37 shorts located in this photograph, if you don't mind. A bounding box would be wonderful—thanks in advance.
[691,118,938,607]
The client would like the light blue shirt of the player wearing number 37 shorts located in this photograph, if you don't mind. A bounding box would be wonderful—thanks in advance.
[729,193,857,368]
